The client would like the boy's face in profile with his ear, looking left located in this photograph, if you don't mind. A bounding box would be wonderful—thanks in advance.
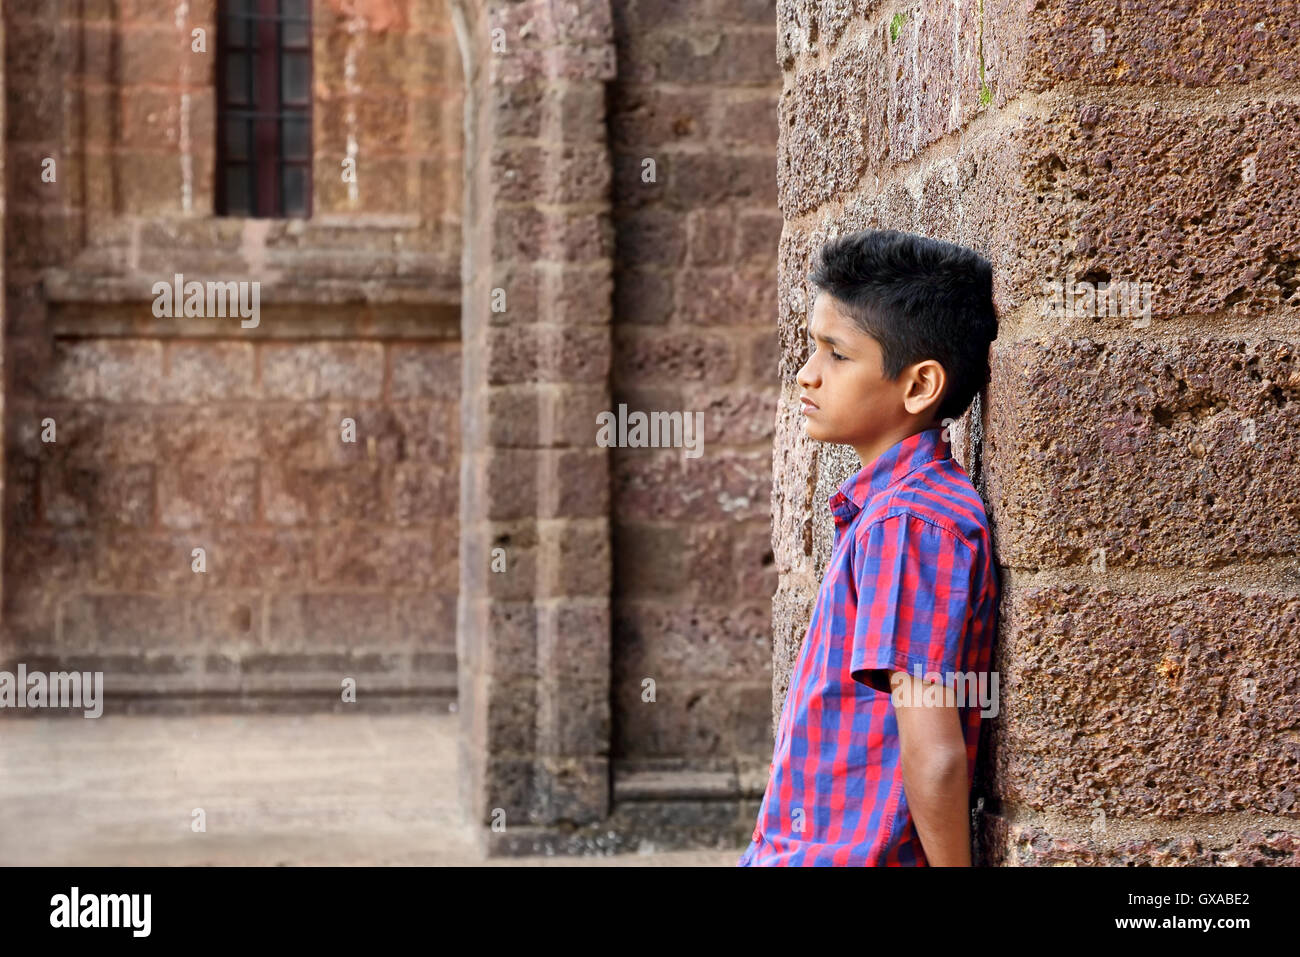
[794,293,945,464]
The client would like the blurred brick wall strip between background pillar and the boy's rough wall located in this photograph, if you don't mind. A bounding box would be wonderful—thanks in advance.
[610,0,781,785]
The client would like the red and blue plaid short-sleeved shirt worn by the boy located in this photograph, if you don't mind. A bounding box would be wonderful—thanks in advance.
[737,428,998,867]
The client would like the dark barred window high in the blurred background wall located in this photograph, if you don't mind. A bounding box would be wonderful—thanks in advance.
[216,0,312,217]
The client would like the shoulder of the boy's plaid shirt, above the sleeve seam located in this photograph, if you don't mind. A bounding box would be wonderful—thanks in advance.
[858,458,991,551]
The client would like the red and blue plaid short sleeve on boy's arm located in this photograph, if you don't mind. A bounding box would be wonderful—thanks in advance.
[849,512,975,693]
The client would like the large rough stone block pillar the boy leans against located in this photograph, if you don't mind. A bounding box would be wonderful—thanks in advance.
[774,0,1300,865]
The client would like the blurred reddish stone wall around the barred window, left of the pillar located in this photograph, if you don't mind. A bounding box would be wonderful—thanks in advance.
[3,0,463,707]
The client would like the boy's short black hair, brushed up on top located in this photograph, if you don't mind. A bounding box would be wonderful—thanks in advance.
[807,229,997,423]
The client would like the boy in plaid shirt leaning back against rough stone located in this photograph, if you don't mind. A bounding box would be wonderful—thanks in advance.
[738,230,998,867]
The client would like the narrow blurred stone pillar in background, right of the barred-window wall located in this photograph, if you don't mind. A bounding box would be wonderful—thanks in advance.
[454,0,614,854]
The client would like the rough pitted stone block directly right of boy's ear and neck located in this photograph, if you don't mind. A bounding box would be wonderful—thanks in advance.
[987,338,1300,568]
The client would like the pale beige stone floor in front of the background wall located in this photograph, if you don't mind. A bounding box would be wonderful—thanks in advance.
[0,714,744,867]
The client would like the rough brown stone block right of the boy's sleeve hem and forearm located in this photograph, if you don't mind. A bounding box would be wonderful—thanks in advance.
[997,575,1300,819]
